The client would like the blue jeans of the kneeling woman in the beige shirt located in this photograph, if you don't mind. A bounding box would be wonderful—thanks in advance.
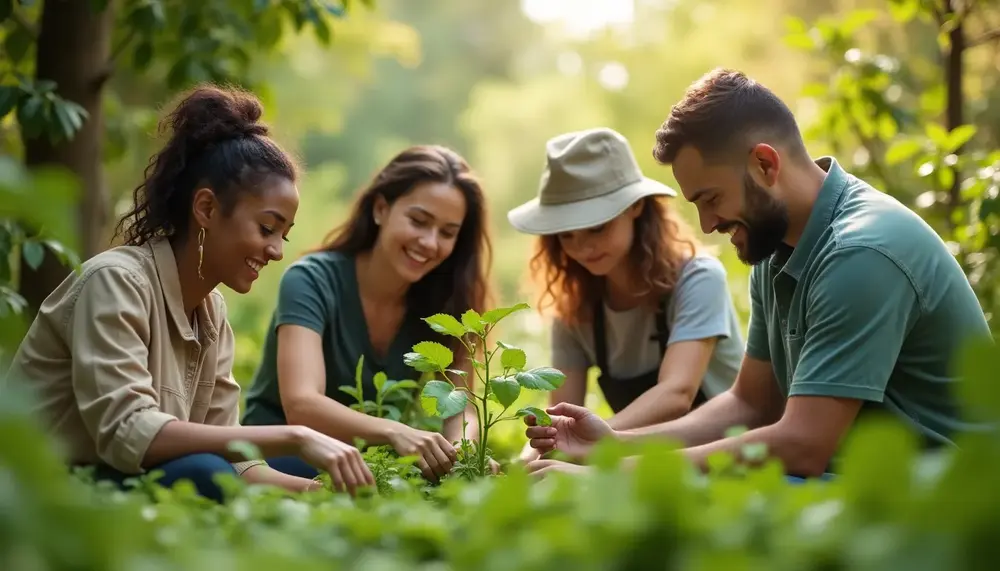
[94,454,319,503]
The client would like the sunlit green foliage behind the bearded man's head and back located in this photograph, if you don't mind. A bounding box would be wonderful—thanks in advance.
[785,5,1000,329]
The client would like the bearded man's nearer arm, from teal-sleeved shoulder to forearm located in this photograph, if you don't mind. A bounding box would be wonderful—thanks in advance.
[686,247,919,476]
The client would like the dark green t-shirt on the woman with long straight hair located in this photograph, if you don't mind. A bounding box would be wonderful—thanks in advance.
[243,252,440,425]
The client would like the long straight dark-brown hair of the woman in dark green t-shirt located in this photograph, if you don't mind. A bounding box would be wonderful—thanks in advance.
[314,145,493,324]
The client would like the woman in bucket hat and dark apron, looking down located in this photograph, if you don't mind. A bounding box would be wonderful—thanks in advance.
[508,128,743,461]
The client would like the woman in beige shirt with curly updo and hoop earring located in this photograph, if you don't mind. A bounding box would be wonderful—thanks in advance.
[1,87,374,501]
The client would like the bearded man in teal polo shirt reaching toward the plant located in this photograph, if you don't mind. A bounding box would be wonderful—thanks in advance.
[526,69,991,479]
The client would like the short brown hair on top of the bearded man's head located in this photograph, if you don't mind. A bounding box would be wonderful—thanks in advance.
[653,68,809,165]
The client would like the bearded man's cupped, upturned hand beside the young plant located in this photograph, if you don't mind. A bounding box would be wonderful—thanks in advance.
[524,402,615,458]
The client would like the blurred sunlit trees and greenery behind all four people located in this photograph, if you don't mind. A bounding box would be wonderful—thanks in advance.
[0,0,1000,454]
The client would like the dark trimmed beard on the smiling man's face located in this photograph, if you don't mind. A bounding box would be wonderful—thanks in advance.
[718,173,788,265]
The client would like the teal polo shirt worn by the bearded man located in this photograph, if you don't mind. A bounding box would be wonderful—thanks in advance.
[747,157,990,446]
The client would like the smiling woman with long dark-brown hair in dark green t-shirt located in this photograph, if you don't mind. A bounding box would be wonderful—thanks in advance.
[243,145,496,481]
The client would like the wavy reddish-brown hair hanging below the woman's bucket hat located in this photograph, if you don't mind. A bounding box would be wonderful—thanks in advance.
[530,197,699,324]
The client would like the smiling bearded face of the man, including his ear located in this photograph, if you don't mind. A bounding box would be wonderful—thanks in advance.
[673,146,788,264]
